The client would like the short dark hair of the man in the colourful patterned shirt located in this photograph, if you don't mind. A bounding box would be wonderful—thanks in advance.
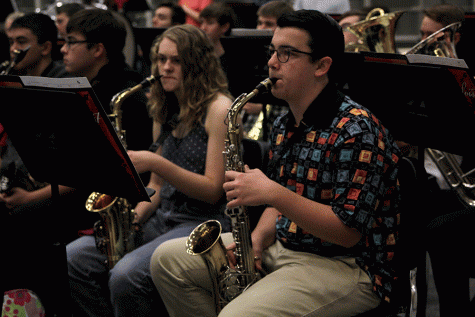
[277,10,345,65]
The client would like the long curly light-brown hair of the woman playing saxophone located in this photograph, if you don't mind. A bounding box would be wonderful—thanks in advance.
[149,24,230,131]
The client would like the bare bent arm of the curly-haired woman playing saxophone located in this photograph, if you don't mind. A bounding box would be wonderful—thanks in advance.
[129,95,231,204]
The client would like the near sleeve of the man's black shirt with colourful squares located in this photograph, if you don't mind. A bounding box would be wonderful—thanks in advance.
[332,116,398,235]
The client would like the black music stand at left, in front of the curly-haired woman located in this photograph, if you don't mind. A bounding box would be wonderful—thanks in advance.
[0,76,150,316]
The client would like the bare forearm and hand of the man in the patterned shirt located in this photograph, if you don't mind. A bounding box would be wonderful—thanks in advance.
[224,167,362,247]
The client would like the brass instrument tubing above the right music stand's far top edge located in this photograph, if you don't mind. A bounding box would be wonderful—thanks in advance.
[406,22,462,58]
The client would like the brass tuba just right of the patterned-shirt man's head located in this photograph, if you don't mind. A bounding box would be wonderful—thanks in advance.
[343,8,405,53]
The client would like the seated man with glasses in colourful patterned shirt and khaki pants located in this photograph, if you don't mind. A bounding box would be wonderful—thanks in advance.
[151,10,400,317]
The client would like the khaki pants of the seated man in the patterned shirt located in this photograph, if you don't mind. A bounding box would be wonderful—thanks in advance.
[151,233,380,317]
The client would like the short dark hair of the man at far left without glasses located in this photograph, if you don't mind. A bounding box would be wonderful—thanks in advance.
[10,13,58,45]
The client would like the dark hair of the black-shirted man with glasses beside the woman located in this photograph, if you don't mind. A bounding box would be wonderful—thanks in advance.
[66,9,127,60]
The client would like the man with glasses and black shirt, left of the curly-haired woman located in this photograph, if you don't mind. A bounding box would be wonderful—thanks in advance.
[61,9,152,150]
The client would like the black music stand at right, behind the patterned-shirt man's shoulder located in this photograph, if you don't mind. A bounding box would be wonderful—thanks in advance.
[340,52,475,155]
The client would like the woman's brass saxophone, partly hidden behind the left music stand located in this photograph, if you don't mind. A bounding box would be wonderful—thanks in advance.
[86,76,157,269]
